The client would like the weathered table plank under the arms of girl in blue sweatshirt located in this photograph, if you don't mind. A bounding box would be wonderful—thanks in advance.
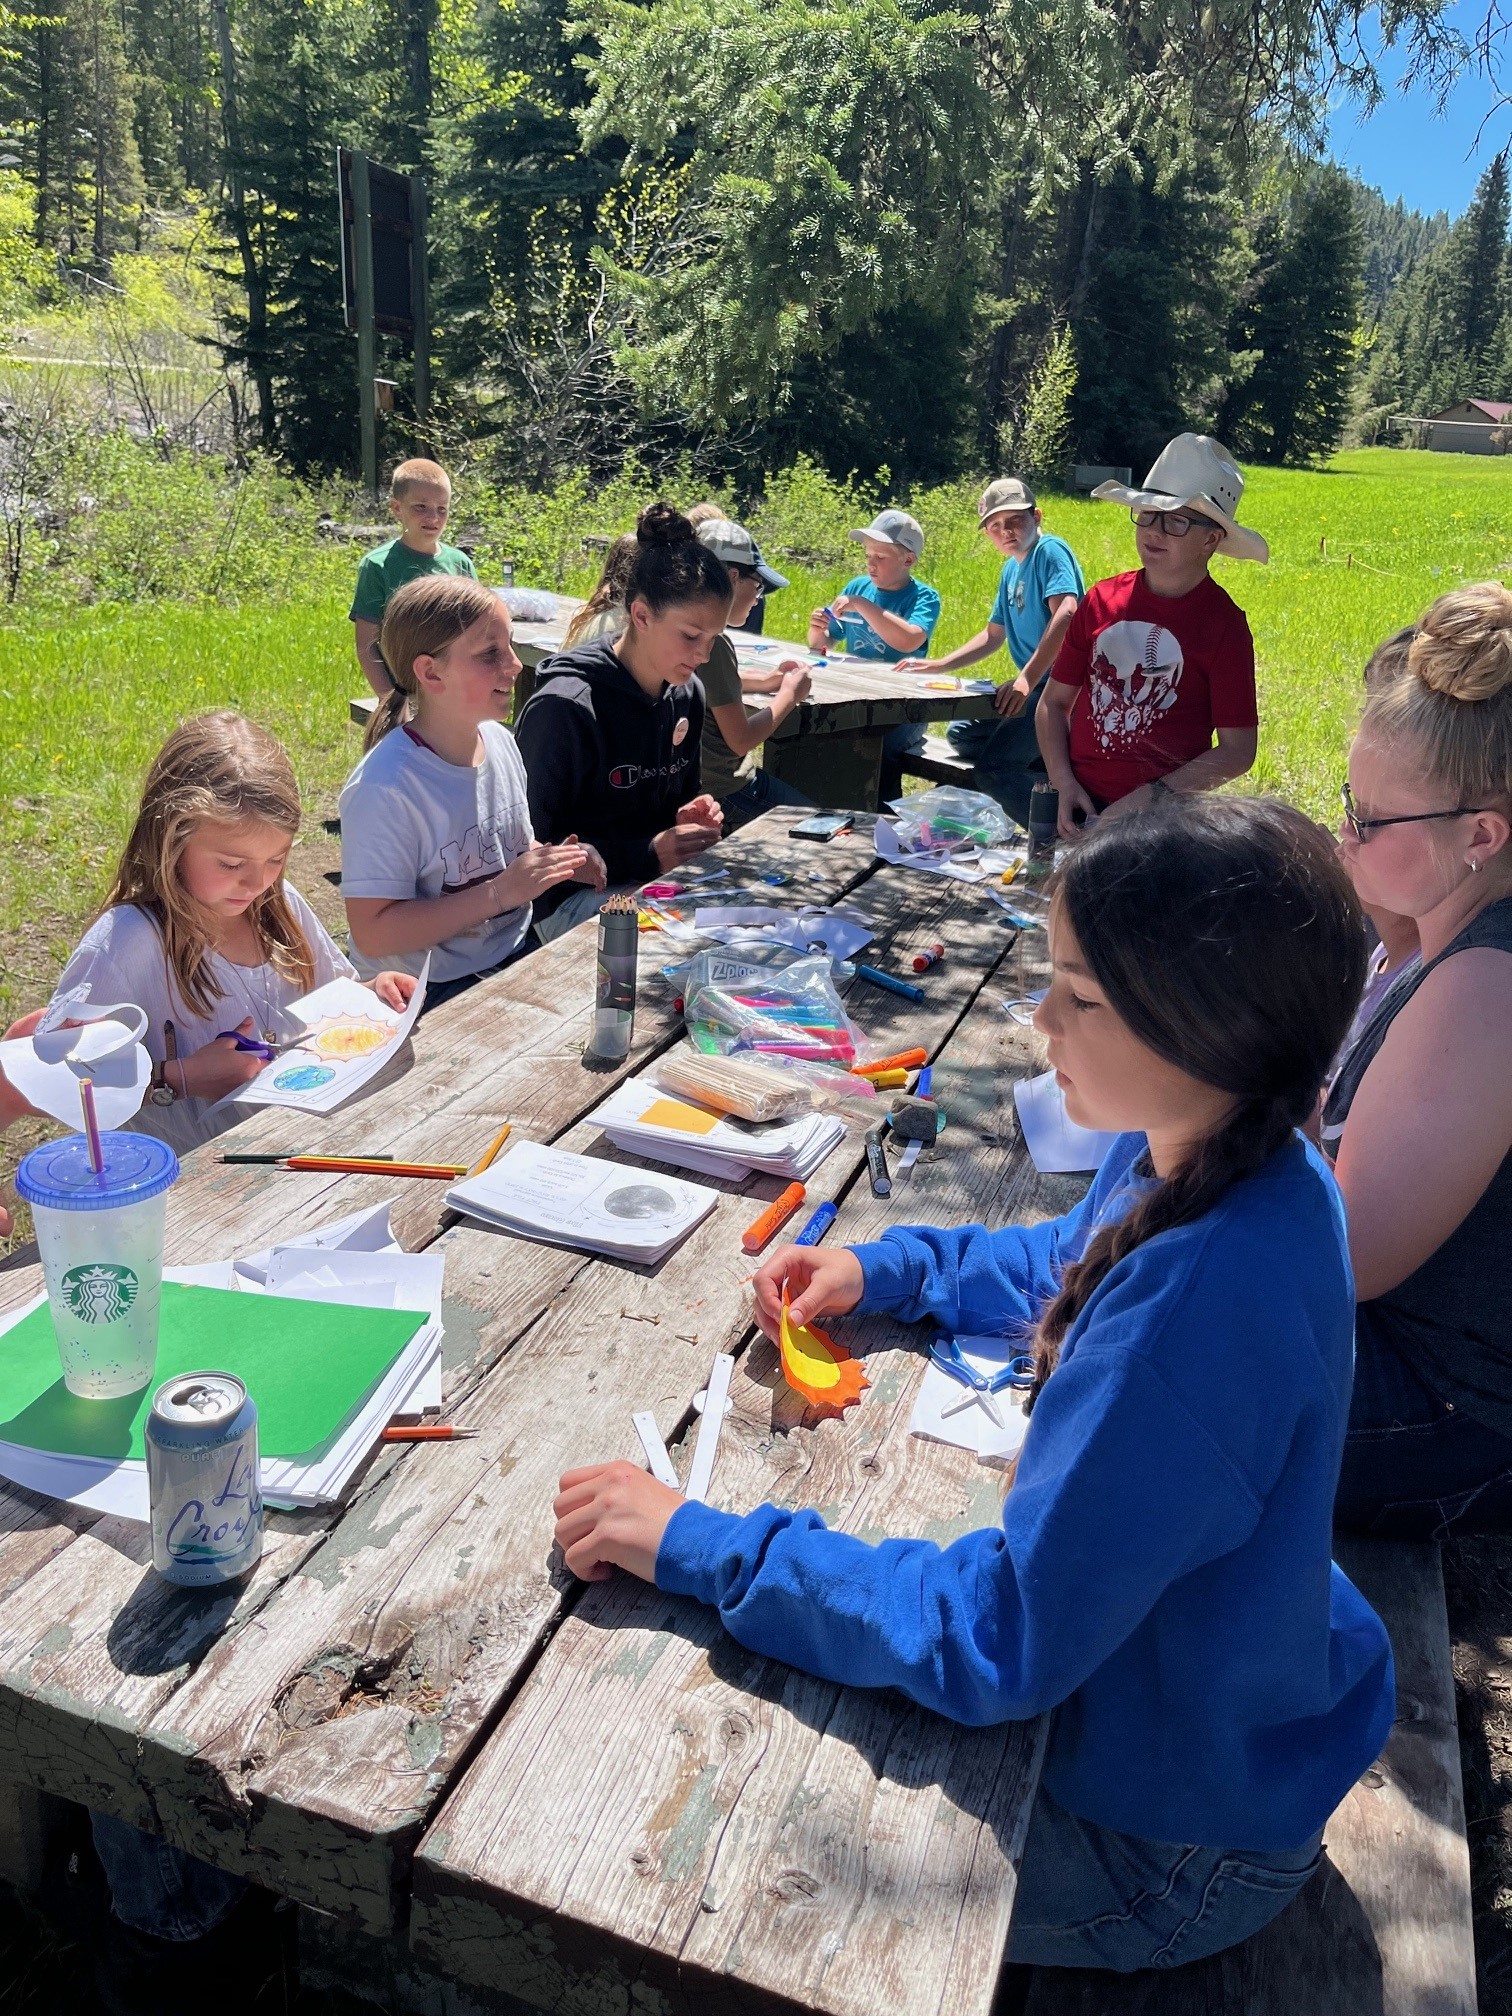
[411,943,1083,2016]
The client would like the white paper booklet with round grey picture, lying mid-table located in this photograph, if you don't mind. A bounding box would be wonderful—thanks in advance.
[446,1141,720,1266]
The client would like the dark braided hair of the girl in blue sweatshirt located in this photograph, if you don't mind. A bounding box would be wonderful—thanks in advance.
[1034,796,1365,1393]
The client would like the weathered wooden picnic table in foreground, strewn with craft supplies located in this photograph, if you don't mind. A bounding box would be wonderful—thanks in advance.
[0,814,1056,2016]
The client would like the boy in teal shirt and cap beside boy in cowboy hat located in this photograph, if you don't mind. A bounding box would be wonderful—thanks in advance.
[903,476,1087,827]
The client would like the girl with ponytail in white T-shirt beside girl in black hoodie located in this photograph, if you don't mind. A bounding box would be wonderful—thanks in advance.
[341,575,603,1006]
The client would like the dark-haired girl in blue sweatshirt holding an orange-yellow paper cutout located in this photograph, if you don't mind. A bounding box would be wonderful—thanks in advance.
[556,796,1395,1970]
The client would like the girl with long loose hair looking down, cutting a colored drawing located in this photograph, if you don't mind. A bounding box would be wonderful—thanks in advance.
[52,714,415,1151]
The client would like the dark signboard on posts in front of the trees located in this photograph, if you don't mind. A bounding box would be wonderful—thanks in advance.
[337,147,431,494]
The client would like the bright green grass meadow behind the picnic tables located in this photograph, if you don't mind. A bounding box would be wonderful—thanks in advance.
[0,450,1512,1040]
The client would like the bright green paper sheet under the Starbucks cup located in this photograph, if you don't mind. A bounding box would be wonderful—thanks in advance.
[0,1280,429,1462]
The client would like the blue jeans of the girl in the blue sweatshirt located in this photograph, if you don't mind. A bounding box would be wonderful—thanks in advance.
[1006,1786,1322,1974]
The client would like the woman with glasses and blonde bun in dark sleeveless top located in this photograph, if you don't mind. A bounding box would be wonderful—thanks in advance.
[1322,581,1512,1538]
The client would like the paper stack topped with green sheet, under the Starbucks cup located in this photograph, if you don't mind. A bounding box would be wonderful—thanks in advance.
[0,1206,444,1520]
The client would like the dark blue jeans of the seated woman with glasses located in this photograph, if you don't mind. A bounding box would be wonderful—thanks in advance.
[1335,1302,1512,1540]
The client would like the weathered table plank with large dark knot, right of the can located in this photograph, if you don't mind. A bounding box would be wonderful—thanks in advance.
[0,842,1020,1929]
